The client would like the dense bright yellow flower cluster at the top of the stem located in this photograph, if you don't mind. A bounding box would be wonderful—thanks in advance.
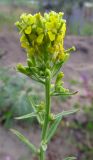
[16,11,69,66]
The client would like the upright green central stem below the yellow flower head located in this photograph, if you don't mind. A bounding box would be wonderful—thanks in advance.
[40,72,51,160]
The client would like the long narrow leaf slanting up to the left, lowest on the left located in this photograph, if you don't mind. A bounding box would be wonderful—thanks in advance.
[10,129,37,153]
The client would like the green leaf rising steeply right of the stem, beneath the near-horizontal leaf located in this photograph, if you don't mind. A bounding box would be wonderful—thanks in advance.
[46,115,62,142]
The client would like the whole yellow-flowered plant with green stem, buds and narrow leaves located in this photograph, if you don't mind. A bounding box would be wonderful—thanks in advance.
[11,11,77,160]
